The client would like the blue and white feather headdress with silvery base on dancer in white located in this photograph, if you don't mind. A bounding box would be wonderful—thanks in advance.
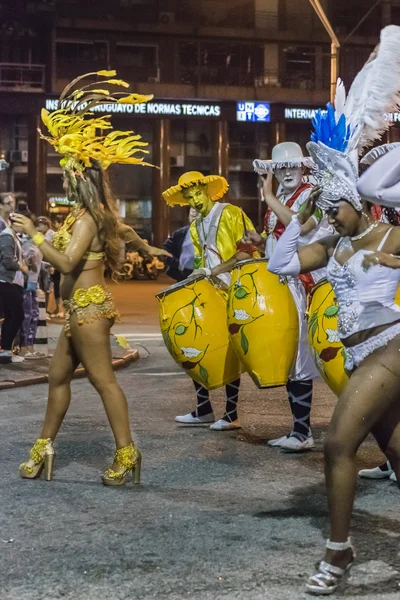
[307,25,400,210]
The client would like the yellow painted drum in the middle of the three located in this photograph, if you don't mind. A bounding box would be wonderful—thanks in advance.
[228,259,299,388]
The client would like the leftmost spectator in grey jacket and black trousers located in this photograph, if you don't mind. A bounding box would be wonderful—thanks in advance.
[0,209,28,363]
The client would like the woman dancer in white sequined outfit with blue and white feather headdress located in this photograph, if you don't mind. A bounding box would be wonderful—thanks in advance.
[269,26,400,595]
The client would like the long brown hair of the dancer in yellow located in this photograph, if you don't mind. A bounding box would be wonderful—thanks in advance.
[64,161,121,273]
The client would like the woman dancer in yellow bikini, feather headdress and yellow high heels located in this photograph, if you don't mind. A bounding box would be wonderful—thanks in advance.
[15,71,165,485]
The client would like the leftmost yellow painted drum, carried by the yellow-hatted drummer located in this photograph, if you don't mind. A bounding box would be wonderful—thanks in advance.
[156,276,241,390]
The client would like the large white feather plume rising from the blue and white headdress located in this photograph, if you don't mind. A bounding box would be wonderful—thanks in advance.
[342,25,400,153]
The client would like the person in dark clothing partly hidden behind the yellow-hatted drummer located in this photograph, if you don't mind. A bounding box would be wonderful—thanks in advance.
[163,208,196,281]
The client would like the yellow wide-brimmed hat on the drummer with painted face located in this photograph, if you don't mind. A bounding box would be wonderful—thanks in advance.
[162,171,229,206]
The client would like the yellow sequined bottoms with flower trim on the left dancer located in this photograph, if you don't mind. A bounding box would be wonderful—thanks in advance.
[63,285,120,336]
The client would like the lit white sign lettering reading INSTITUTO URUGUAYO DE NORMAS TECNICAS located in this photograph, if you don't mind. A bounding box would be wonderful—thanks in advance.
[46,98,221,117]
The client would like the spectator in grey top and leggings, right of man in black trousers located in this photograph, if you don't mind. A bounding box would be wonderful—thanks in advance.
[20,221,44,359]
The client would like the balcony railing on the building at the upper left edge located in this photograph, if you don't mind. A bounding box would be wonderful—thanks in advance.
[0,63,46,92]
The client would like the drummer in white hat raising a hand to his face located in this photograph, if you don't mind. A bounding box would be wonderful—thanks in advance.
[248,142,332,452]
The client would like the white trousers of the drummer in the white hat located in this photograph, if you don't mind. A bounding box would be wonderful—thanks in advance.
[288,277,319,381]
